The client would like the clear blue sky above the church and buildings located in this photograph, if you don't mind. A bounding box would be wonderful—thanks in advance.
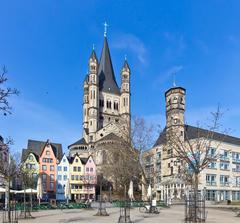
[0,0,240,153]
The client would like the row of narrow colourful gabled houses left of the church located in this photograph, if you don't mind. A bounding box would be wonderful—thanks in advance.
[22,140,97,201]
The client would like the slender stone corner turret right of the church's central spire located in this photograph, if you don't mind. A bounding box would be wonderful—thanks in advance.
[121,58,131,134]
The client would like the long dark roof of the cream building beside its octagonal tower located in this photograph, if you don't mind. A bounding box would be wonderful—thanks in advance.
[154,125,240,147]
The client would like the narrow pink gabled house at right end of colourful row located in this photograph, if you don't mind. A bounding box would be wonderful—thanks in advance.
[83,156,97,199]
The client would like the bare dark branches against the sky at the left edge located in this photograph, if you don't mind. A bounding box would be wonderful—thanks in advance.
[0,66,19,115]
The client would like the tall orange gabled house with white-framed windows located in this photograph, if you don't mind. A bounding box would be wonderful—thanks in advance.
[39,141,58,199]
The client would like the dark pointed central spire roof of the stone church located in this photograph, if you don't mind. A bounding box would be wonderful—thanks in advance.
[98,37,120,95]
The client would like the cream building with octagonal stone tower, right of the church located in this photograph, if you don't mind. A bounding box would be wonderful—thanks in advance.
[144,87,240,202]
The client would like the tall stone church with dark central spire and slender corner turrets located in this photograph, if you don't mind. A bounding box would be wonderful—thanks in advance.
[68,33,131,169]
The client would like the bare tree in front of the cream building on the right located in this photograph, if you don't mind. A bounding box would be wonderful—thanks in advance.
[165,107,226,222]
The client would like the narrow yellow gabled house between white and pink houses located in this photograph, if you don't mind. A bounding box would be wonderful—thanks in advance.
[70,154,85,200]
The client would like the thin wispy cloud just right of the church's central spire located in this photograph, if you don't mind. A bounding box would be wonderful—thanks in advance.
[113,34,148,65]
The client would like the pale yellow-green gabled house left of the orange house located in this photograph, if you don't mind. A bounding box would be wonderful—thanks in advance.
[22,151,39,188]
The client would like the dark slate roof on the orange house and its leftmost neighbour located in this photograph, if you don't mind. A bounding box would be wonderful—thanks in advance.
[22,139,63,160]
